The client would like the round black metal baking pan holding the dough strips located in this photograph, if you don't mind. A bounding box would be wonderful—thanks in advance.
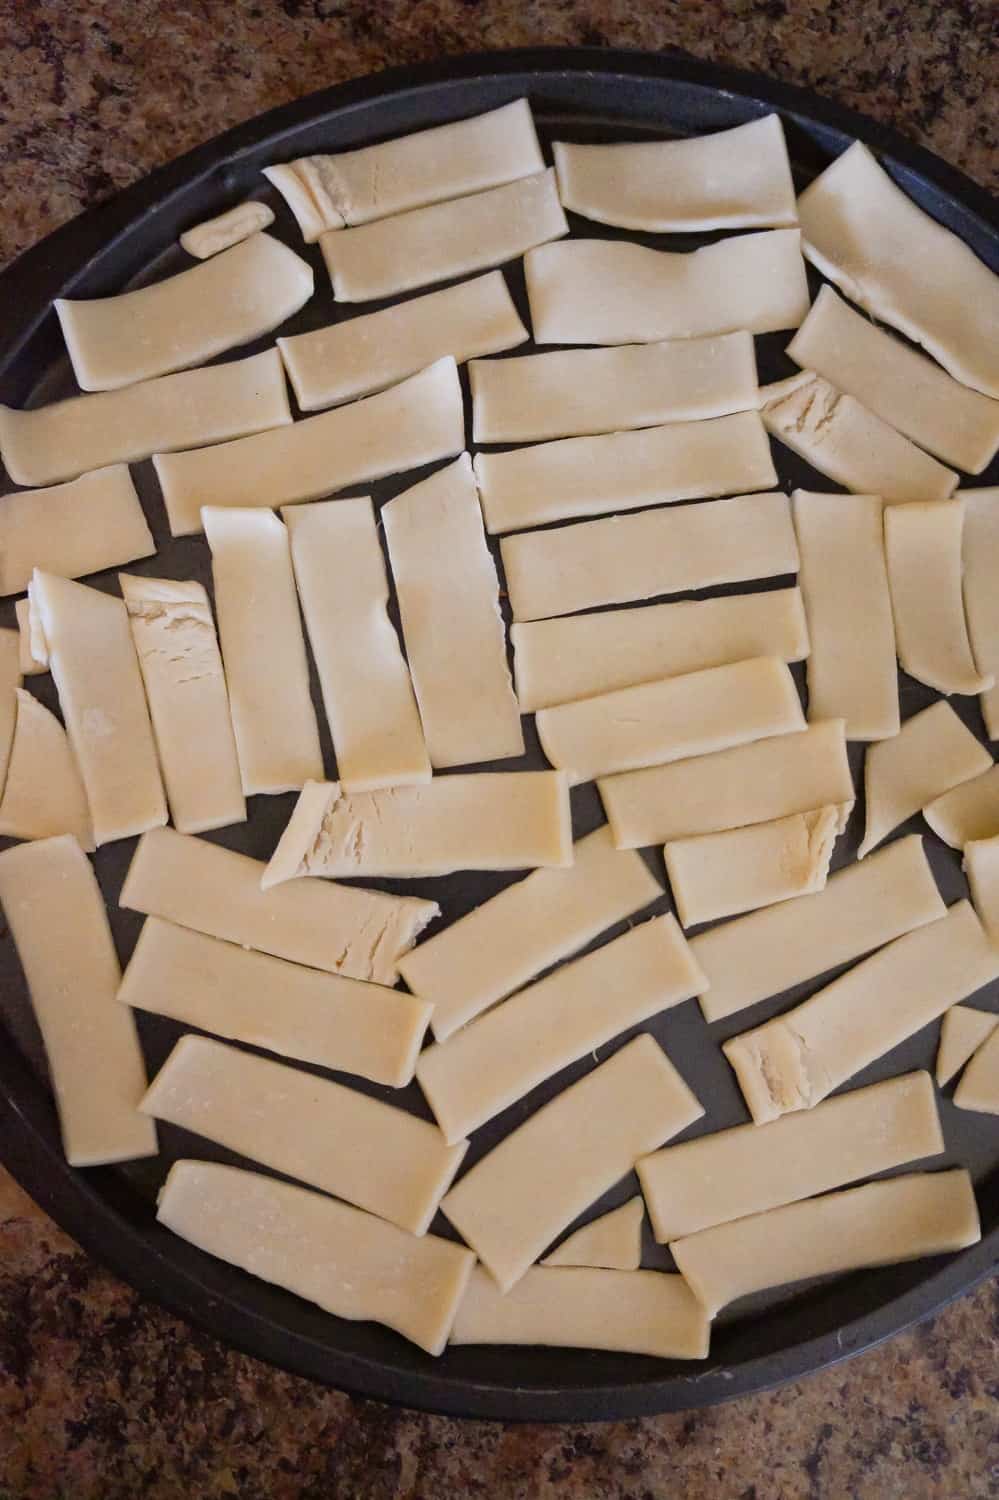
[0,50,999,1421]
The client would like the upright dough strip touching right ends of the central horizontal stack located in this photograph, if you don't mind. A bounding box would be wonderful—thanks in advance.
[792,489,899,740]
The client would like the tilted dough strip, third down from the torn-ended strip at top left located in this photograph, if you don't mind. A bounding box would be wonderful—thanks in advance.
[278,272,530,411]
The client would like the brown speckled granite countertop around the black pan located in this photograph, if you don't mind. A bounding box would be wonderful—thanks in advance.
[0,0,999,1500]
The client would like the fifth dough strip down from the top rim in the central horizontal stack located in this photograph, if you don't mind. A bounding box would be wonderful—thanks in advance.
[500,494,798,620]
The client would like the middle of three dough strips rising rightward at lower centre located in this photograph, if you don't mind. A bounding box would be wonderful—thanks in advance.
[417,914,707,1142]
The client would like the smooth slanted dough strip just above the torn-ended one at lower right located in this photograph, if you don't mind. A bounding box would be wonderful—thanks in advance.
[690,834,947,1022]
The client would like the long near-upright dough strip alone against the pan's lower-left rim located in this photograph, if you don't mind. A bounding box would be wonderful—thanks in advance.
[0,834,156,1167]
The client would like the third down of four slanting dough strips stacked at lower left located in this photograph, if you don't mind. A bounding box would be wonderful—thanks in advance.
[140,1038,468,1235]
